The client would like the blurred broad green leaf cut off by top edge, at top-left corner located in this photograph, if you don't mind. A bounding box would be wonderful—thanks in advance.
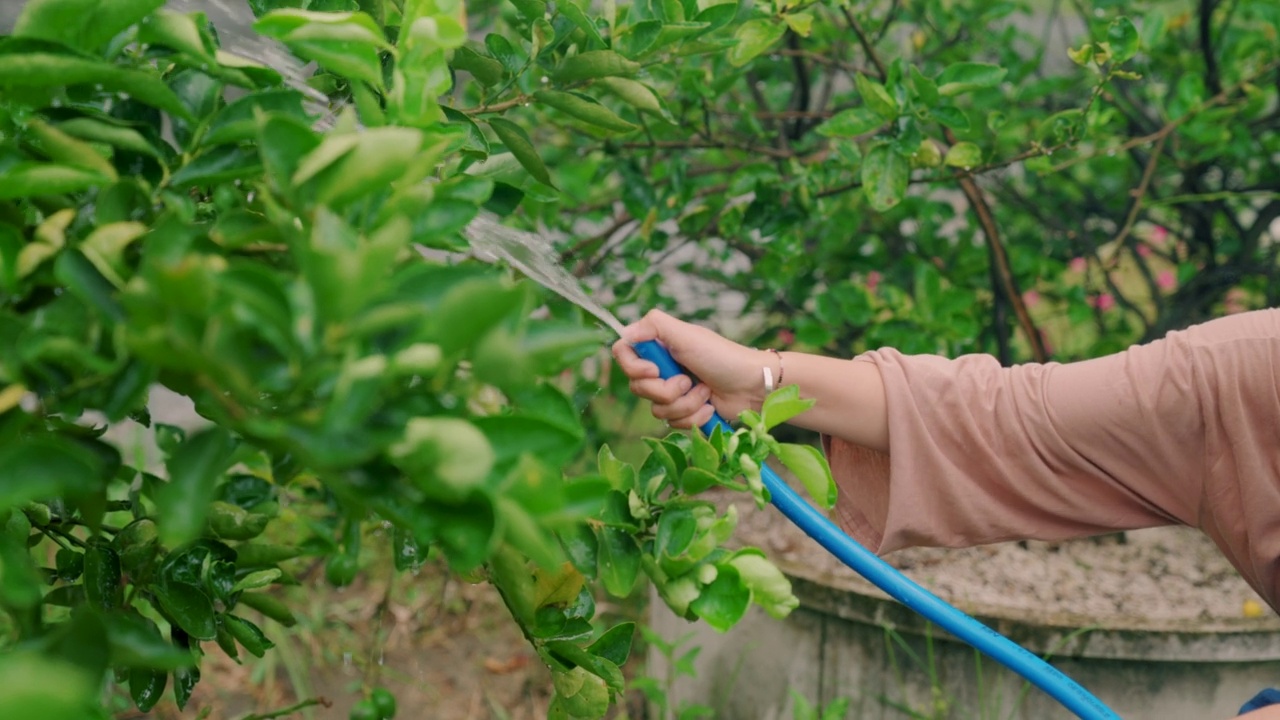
[13,0,164,53]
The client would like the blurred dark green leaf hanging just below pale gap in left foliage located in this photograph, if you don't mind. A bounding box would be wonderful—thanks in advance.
[156,427,236,543]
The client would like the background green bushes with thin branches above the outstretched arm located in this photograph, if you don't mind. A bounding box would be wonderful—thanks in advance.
[486,0,1280,361]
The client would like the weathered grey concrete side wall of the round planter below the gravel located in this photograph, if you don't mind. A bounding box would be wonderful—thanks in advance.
[649,556,1280,720]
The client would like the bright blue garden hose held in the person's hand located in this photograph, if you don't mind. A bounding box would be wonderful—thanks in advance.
[635,340,1120,720]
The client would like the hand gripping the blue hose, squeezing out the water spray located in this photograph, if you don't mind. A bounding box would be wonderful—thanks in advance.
[613,310,777,428]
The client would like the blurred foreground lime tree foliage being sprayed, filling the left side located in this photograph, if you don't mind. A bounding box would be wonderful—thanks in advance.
[0,0,835,720]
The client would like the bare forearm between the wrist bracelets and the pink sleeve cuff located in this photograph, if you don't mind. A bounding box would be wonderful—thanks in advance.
[767,352,888,452]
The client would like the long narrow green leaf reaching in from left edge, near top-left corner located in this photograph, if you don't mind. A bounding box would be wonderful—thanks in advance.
[0,52,192,120]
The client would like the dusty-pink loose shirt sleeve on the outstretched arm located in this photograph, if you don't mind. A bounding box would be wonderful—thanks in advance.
[823,303,1280,609]
